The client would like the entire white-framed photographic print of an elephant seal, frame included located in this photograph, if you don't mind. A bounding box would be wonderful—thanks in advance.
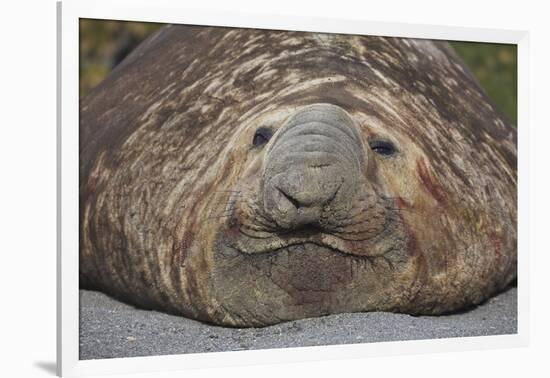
[58,1,528,376]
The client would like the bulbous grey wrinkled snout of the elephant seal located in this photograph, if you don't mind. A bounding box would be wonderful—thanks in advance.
[263,104,366,229]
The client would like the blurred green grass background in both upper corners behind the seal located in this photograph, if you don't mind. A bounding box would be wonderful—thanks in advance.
[79,19,517,124]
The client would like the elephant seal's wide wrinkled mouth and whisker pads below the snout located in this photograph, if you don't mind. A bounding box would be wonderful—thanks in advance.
[218,186,408,266]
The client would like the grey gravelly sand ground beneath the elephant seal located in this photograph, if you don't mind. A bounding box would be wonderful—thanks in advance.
[80,287,517,359]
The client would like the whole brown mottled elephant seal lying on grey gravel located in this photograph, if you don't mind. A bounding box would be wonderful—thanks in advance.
[80,26,517,327]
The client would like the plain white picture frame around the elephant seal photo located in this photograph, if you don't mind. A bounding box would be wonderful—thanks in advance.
[57,0,529,376]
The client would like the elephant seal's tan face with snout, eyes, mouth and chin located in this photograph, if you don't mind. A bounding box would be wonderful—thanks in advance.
[207,103,422,324]
